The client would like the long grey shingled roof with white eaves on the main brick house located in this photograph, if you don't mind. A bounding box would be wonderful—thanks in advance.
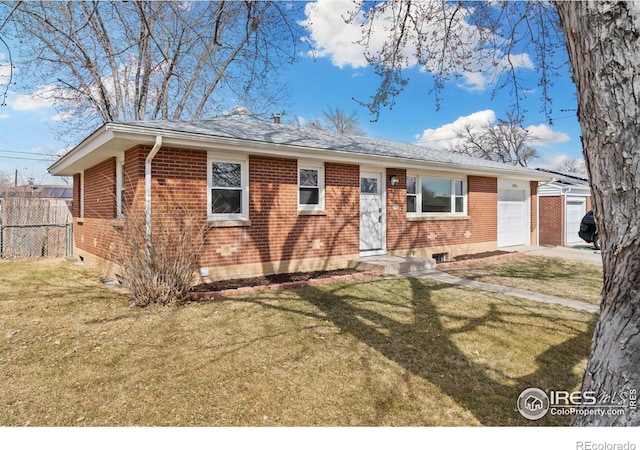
[49,118,550,180]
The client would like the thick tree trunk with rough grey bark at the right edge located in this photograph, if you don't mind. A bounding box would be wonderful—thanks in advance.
[556,2,640,425]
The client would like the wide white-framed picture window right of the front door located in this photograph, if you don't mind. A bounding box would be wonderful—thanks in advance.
[407,175,467,216]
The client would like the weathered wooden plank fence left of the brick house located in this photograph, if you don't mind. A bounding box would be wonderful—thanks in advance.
[0,198,73,258]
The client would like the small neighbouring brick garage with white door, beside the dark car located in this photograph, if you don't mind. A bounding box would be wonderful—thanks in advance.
[538,169,591,246]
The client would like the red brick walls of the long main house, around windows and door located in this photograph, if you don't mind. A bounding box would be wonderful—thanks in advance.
[74,146,536,271]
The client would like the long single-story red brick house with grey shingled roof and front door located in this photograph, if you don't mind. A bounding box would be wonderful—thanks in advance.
[49,118,552,279]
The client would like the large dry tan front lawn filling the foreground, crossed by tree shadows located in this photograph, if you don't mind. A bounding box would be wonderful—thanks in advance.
[0,260,595,426]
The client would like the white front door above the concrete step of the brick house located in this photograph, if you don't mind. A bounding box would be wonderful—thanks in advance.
[360,172,386,255]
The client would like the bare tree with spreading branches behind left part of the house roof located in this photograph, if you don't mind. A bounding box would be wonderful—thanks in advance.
[6,1,300,134]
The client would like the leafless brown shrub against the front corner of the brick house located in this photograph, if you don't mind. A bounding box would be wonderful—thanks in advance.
[120,205,206,307]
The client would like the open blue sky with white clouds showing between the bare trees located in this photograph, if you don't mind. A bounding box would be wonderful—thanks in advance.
[0,0,582,184]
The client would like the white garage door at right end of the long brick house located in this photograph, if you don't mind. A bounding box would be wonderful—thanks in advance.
[498,189,528,247]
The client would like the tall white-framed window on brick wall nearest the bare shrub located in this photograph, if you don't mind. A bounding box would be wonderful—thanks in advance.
[207,153,249,220]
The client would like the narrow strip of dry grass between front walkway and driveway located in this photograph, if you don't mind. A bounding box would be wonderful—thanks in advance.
[443,255,603,305]
